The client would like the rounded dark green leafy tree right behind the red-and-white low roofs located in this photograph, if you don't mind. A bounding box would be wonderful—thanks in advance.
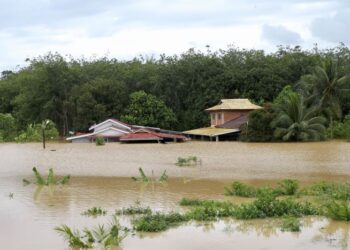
[122,91,176,128]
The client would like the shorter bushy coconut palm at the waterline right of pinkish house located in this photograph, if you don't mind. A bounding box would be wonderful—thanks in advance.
[271,93,327,141]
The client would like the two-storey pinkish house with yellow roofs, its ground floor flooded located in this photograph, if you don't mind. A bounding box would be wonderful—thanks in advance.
[184,99,261,141]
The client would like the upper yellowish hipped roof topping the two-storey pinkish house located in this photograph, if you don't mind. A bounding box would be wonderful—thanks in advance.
[206,99,262,111]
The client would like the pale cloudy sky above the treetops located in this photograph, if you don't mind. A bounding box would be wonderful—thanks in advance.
[0,0,350,71]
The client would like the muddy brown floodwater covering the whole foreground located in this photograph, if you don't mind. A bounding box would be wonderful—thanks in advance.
[0,141,350,250]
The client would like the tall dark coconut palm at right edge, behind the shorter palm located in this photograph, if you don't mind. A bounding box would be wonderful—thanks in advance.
[300,59,350,136]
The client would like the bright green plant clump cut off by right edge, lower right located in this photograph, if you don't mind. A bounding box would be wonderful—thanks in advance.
[325,200,350,221]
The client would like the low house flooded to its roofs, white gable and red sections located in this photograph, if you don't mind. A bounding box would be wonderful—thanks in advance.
[67,119,188,143]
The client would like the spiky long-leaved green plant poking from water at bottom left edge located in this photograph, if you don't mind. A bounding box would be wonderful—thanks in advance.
[55,216,130,249]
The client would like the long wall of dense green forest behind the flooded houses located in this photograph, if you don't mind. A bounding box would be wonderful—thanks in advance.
[0,44,350,139]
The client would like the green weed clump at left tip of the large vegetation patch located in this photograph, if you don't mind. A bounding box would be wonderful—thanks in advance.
[132,212,188,232]
